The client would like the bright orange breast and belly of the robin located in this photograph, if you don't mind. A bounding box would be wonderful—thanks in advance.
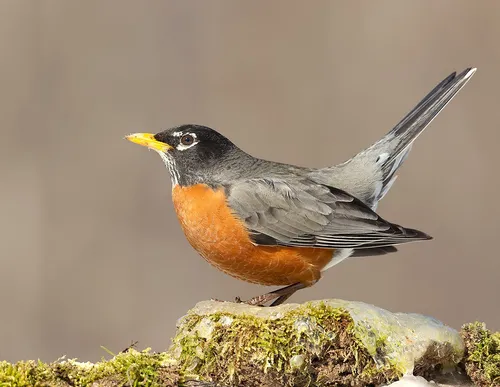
[172,184,333,285]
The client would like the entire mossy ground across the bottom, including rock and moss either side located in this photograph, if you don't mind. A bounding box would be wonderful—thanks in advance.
[0,300,500,387]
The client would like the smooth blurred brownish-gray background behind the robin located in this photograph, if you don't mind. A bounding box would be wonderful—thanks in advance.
[0,0,500,361]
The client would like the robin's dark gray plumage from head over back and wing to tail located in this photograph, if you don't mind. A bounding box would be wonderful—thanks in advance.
[149,69,476,268]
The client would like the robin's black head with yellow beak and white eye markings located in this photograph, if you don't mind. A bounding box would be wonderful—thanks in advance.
[127,125,248,185]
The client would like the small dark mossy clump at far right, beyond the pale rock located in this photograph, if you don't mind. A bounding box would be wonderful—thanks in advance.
[462,322,500,386]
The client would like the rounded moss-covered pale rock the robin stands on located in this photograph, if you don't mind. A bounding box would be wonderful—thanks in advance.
[171,300,464,386]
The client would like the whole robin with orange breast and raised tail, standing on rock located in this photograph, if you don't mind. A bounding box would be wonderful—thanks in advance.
[126,68,476,305]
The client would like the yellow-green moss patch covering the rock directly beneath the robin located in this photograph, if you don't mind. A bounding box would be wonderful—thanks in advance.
[171,303,402,386]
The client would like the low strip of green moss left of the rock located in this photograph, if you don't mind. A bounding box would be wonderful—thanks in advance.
[0,349,178,387]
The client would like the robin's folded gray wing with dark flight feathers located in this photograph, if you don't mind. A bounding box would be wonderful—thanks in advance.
[226,178,430,249]
